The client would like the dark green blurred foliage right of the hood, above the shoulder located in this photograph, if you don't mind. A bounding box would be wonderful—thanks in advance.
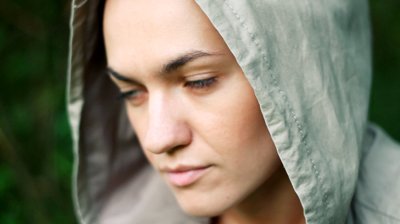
[370,0,400,141]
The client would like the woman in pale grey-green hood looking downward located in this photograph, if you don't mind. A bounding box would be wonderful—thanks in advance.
[69,0,400,223]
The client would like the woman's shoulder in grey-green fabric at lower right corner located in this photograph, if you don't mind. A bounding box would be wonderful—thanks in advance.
[350,124,400,224]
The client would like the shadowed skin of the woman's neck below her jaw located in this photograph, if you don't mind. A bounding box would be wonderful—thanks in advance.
[216,166,305,224]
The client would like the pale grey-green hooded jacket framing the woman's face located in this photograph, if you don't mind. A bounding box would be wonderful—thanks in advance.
[68,0,400,224]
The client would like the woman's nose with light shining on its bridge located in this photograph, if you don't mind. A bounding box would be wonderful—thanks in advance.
[142,94,192,154]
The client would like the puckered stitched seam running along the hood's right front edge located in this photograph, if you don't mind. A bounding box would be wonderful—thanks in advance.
[224,0,328,215]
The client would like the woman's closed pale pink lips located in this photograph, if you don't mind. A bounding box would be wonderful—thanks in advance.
[166,166,210,187]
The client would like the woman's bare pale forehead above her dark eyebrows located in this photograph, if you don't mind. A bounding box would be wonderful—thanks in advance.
[104,0,230,79]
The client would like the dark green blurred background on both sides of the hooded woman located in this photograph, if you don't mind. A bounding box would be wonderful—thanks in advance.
[0,0,400,224]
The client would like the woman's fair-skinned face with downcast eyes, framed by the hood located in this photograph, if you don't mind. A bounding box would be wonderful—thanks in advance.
[104,0,280,216]
